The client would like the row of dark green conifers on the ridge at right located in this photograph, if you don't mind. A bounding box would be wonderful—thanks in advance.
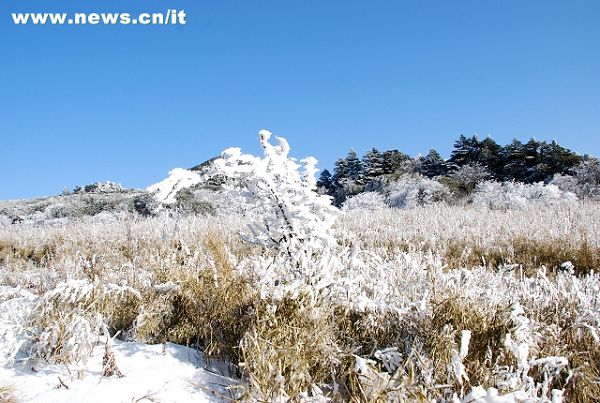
[318,135,600,204]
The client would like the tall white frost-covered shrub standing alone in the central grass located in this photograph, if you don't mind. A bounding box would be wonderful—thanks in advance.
[211,130,336,256]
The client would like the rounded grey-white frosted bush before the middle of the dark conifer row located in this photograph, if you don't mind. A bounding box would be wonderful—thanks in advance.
[384,175,450,208]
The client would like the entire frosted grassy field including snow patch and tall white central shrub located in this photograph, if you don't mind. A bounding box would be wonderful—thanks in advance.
[0,132,600,402]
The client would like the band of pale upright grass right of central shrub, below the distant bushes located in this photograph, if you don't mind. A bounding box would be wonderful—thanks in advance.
[338,203,600,274]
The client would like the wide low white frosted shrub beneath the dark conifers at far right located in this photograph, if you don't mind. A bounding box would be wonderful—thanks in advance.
[473,181,577,209]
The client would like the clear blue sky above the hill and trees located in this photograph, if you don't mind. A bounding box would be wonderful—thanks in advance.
[0,0,600,199]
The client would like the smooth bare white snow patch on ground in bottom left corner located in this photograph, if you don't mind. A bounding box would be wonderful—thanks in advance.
[0,287,239,403]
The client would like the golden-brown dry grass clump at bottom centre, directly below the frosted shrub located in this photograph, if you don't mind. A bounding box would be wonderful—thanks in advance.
[240,296,338,401]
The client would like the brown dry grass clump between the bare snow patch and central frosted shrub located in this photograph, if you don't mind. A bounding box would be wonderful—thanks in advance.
[136,233,256,361]
